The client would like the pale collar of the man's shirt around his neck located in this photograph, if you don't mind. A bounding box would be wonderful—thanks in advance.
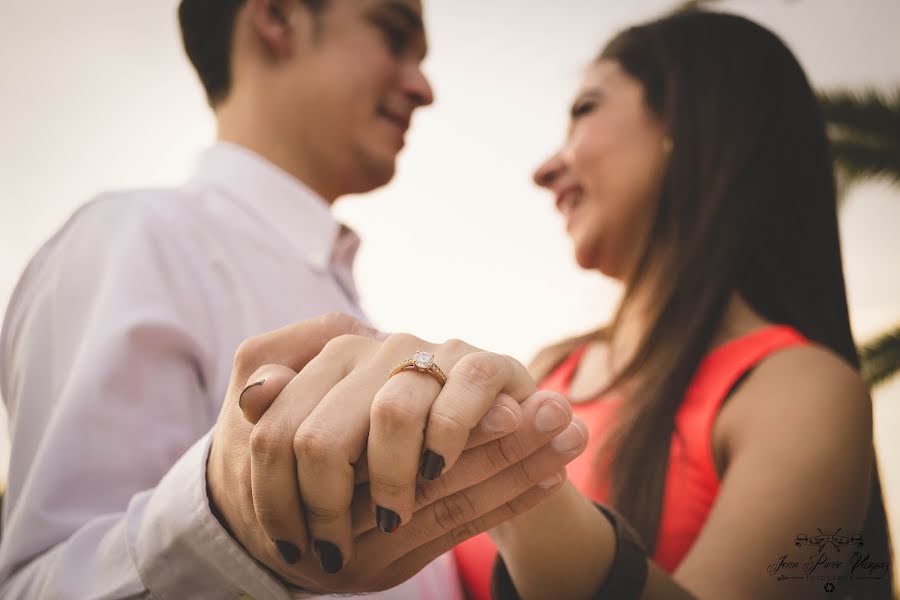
[191,142,359,271]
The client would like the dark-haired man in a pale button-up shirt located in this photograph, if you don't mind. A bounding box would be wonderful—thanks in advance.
[0,0,584,600]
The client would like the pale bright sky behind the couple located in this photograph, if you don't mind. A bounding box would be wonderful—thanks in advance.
[0,0,900,556]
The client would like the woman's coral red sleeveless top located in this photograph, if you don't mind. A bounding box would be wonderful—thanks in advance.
[453,325,809,600]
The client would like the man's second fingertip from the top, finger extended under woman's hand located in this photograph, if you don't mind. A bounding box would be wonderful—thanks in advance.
[353,391,586,535]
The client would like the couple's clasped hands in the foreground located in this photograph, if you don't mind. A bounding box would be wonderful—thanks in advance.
[207,314,587,593]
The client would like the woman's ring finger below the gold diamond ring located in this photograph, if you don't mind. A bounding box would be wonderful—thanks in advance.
[367,364,441,533]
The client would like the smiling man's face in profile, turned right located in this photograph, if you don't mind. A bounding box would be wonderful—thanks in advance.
[270,0,433,195]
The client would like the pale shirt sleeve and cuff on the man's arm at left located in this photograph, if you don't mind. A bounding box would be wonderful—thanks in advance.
[0,197,296,600]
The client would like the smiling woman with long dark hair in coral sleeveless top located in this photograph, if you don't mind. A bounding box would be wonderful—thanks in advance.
[241,11,891,599]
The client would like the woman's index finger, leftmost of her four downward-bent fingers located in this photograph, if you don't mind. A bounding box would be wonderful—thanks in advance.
[250,338,374,566]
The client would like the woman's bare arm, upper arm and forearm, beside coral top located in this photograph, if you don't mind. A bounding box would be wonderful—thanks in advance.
[493,347,887,600]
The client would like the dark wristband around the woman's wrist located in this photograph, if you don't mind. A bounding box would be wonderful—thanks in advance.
[491,502,647,600]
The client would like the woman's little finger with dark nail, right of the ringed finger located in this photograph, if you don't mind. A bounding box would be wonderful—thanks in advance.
[421,352,535,479]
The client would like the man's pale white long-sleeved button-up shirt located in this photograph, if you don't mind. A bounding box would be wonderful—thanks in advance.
[0,143,461,600]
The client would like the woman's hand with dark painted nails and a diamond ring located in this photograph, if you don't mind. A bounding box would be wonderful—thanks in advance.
[243,334,535,570]
